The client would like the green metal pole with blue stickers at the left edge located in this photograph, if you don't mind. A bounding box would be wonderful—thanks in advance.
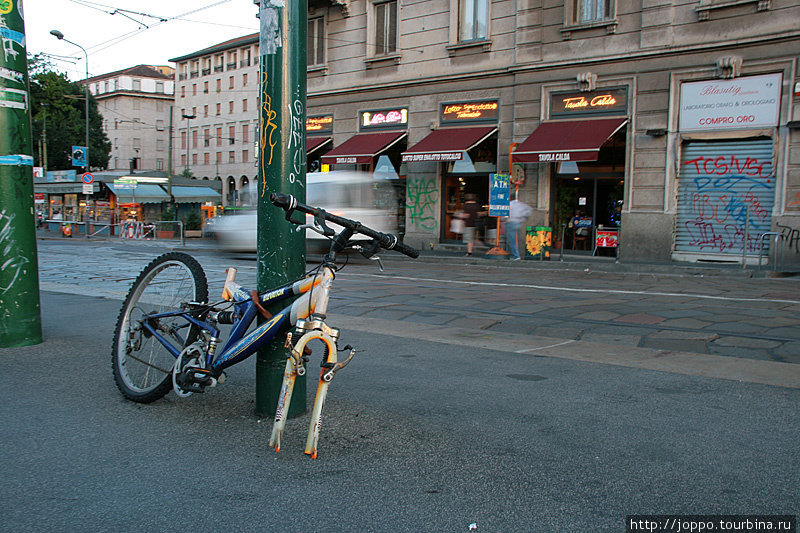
[0,0,42,348]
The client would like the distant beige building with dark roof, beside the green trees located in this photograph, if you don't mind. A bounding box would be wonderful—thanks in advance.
[87,65,174,172]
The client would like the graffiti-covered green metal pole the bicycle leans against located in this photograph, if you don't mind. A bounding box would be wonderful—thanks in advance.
[256,0,308,416]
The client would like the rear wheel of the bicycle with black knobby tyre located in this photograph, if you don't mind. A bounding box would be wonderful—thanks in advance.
[111,252,208,403]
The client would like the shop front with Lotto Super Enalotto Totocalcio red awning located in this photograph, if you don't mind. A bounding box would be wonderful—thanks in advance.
[403,100,499,244]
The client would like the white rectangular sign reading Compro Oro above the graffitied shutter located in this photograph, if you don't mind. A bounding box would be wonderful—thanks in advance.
[678,74,782,131]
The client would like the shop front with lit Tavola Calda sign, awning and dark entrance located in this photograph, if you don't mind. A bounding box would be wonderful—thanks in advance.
[513,88,628,255]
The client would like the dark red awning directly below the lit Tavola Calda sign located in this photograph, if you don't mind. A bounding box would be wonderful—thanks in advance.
[513,117,628,163]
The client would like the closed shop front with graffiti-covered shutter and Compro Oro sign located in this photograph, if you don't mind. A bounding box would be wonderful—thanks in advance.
[673,73,782,262]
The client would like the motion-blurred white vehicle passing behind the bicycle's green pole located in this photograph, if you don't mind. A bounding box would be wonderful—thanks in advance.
[214,170,405,252]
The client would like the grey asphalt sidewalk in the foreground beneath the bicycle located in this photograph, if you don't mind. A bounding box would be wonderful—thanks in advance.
[0,292,800,533]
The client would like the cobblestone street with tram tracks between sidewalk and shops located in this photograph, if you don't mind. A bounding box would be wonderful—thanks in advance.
[32,235,800,363]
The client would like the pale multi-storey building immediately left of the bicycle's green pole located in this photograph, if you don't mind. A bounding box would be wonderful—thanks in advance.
[170,33,258,206]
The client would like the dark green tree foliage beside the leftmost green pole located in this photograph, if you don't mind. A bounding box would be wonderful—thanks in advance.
[28,55,111,170]
